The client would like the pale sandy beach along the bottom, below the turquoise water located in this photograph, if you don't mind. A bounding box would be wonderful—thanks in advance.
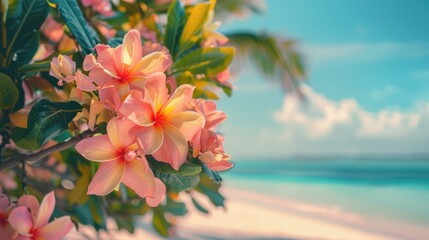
[66,188,429,240]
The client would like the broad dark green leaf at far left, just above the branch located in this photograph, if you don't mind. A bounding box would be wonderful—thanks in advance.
[12,99,82,150]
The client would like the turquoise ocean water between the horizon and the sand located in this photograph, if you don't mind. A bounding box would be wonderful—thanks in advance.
[223,158,429,239]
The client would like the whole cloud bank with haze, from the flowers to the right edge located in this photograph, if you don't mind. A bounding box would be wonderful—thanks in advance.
[224,86,429,159]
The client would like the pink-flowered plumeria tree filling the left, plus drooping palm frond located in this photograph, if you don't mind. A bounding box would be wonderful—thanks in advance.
[0,0,303,239]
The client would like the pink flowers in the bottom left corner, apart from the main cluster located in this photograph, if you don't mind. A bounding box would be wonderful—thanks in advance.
[0,189,73,240]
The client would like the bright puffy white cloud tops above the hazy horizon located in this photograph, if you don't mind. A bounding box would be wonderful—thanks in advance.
[275,86,422,138]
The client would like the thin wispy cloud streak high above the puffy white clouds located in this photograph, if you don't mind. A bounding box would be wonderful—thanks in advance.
[302,41,429,64]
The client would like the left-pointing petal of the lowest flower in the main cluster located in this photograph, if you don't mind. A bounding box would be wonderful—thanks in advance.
[75,135,120,162]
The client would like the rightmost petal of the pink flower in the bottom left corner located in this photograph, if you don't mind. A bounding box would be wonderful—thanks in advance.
[38,216,73,240]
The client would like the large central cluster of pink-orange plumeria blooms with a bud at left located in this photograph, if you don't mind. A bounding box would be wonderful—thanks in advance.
[51,29,232,206]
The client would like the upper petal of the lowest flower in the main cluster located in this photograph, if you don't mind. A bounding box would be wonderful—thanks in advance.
[107,118,135,152]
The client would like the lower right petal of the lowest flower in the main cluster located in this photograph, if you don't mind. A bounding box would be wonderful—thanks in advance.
[122,159,155,198]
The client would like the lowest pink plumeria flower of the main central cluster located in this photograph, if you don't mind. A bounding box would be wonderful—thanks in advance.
[76,118,165,206]
